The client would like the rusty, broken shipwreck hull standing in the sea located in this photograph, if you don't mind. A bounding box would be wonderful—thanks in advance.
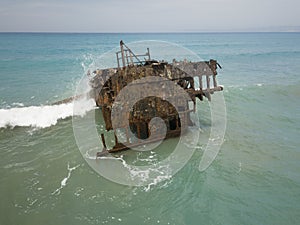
[90,41,223,156]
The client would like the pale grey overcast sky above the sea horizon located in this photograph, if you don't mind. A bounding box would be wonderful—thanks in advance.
[0,0,300,33]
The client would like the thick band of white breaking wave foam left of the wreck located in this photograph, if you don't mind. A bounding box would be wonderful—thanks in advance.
[0,96,95,128]
